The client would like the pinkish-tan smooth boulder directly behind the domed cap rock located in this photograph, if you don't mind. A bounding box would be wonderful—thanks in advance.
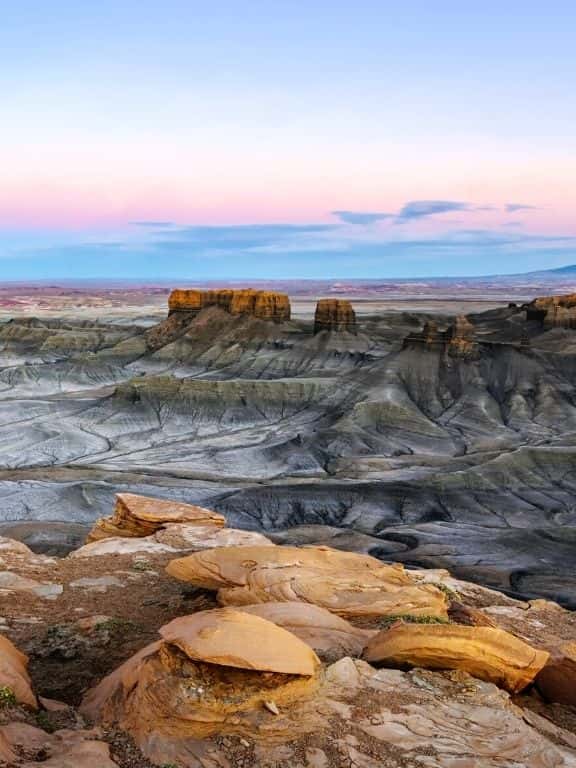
[239,603,375,662]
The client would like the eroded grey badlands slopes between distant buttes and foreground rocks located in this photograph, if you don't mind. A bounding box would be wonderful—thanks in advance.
[0,307,576,608]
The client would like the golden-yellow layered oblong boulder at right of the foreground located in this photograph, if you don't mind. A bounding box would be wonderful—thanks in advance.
[364,622,550,693]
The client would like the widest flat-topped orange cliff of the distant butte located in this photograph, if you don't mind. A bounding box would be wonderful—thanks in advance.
[168,288,290,323]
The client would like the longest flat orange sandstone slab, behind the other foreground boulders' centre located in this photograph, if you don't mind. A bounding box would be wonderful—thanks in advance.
[167,547,448,618]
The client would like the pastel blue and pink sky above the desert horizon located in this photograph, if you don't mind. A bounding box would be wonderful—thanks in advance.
[0,0,576,281]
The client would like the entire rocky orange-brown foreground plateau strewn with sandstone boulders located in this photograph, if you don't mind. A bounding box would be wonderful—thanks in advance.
[0,494,576,768]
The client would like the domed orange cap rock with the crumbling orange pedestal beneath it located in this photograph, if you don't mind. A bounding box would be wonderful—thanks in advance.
[81,609,320,748]
